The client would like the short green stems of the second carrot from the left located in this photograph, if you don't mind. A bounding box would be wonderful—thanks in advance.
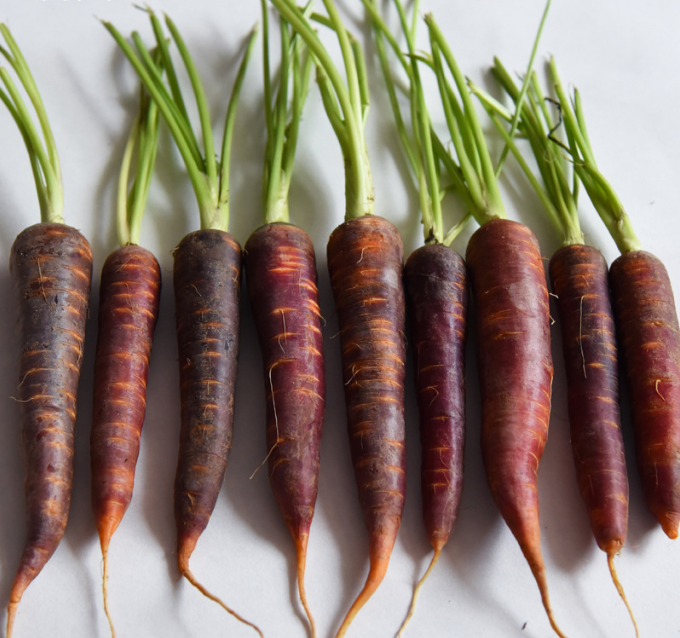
[116,55,162,246]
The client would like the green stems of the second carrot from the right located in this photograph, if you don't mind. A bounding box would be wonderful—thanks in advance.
[468,58,584,245]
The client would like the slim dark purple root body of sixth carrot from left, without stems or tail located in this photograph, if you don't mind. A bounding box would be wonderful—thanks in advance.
[404,244,468,550]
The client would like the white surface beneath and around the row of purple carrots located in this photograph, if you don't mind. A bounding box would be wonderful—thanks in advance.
[0,0,680,638]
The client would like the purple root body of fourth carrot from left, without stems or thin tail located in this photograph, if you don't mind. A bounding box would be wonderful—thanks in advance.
[244,223,325,541]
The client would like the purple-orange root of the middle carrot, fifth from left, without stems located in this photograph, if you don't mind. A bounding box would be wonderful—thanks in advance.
[327,215,406,636]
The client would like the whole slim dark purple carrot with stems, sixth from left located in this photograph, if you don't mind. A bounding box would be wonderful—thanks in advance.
[364,5,469,636]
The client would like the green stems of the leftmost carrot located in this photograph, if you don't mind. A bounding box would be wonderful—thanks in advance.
[0,24,64,223]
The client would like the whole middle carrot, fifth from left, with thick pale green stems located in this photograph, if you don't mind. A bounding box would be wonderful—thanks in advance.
[273,0,406,638]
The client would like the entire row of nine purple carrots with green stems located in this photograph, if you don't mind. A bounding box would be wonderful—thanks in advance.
[0,0,680,638]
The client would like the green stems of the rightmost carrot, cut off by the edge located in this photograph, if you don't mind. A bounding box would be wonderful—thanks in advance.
[550,58,640,253]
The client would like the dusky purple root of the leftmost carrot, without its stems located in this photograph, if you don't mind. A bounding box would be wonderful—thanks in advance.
[9,223,92,615]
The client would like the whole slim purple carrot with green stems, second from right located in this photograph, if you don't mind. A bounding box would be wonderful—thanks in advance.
[472,59,637,633]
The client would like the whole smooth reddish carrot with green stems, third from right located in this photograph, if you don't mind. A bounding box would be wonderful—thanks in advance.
[425,12,564,636]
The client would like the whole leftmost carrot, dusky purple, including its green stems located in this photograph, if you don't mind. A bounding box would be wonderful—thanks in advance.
[0,24,92,638]
